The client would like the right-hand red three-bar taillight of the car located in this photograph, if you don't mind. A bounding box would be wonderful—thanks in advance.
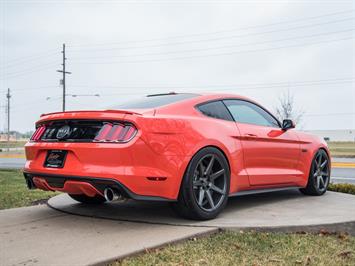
[94,123,137,142]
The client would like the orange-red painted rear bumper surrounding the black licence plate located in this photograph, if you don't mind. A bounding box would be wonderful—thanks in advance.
[24,136,189,200]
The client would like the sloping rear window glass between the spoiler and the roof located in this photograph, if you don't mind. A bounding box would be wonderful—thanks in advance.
[113,93,199,109]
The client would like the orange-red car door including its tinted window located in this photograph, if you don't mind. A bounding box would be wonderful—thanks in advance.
[224,100,302,186]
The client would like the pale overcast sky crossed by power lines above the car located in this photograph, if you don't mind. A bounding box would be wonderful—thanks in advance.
[0,0,355,132]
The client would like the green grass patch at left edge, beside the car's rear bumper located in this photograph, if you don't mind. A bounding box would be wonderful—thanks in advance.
[0,170,56,210]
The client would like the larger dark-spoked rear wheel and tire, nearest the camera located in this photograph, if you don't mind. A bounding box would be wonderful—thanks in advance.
[173,147,230,220]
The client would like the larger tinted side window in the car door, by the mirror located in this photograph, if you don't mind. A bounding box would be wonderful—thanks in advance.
[223,100,280,127]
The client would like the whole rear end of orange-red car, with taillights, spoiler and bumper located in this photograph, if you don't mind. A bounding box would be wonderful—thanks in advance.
[24,110,189,200]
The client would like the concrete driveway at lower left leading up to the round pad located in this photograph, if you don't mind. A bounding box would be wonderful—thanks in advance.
[0,205,217,266]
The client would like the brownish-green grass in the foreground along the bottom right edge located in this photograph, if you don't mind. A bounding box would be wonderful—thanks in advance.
[112,231,355,266]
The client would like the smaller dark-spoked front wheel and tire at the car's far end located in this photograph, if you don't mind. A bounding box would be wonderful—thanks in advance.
[300,149,330,196]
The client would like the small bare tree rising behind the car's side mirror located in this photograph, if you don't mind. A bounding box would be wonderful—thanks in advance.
[275,90,304,124]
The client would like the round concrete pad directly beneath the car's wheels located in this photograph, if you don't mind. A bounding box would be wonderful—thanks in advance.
[48,190,355,229]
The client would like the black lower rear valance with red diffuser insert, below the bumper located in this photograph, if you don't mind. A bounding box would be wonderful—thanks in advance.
[23,172,174,201]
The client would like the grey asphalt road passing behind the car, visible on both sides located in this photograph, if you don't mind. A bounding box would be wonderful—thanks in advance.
[0,158,355,184]
